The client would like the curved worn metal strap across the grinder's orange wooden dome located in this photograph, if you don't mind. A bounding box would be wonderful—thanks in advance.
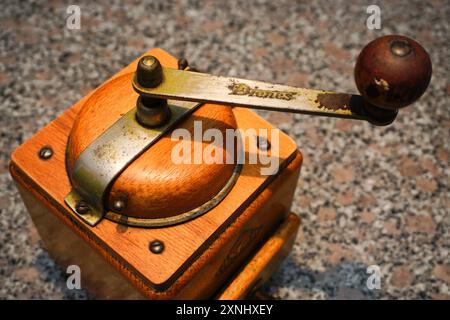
[64,100,200,226]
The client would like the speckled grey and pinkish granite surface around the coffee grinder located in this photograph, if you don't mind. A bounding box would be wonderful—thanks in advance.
[0,0,450,299]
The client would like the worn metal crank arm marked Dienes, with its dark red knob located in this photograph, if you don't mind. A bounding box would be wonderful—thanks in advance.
[133,36,432,125]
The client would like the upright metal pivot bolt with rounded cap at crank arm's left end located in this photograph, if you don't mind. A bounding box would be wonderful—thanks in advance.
[135,56,170,127]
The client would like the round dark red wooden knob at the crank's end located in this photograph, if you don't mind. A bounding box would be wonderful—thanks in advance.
[355,35,432,109]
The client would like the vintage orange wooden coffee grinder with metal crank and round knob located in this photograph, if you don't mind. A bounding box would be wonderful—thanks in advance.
[10,36,431,299]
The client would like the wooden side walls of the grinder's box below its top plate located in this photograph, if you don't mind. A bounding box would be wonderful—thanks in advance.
[14,153,301,299]
